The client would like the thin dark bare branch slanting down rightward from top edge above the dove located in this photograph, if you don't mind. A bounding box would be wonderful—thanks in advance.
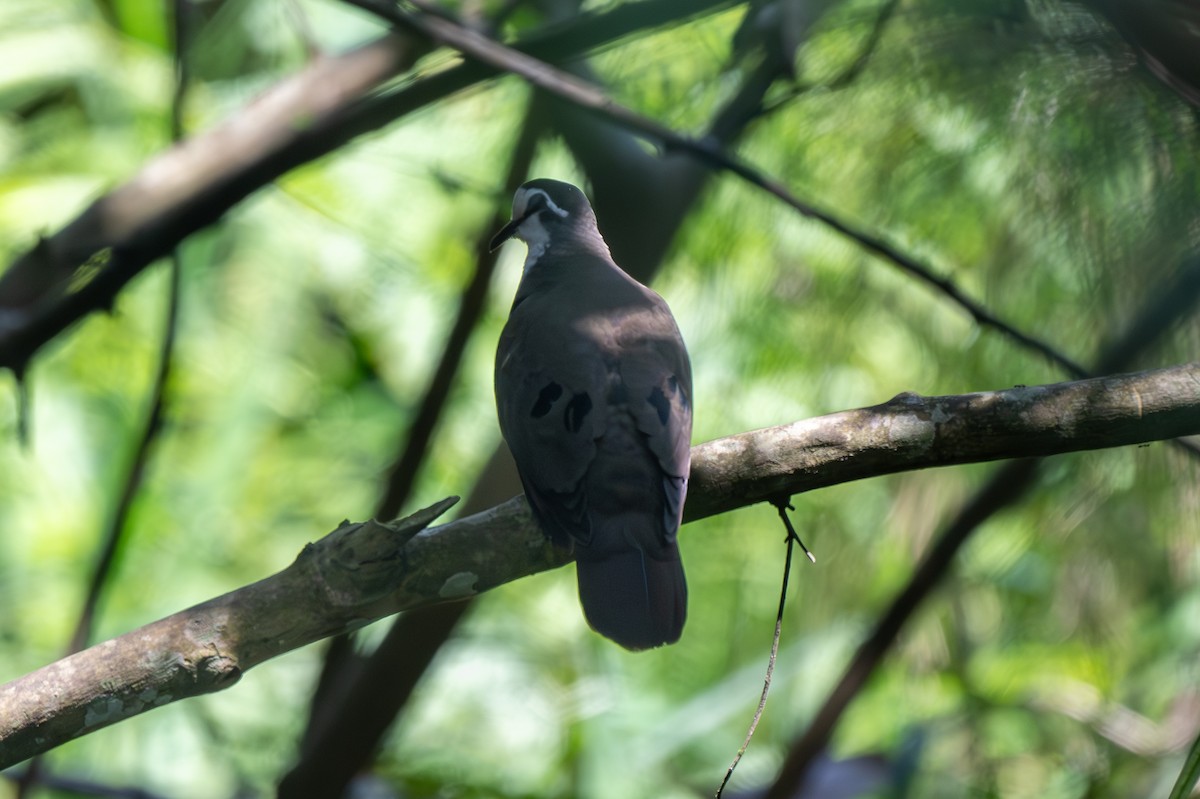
[372,0,1087,377]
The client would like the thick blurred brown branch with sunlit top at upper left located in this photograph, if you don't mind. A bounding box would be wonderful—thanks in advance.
[0,36,422,372]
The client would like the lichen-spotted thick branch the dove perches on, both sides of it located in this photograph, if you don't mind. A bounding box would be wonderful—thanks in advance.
[0,362,1200,769]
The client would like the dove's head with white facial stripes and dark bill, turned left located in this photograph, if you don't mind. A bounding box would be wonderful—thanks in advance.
[491,178,607,260]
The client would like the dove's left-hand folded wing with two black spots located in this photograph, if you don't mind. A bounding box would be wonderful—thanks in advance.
[496,296,607,546]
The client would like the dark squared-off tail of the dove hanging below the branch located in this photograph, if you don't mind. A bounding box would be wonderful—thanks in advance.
[576,542,688,650]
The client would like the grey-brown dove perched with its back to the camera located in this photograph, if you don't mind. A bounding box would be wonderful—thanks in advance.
[491,179,692,651]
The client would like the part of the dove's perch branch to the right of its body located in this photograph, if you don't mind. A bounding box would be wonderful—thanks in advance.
[685,362,1200,521]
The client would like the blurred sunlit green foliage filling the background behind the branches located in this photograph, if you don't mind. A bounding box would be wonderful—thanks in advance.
[0,0,1200,799]
